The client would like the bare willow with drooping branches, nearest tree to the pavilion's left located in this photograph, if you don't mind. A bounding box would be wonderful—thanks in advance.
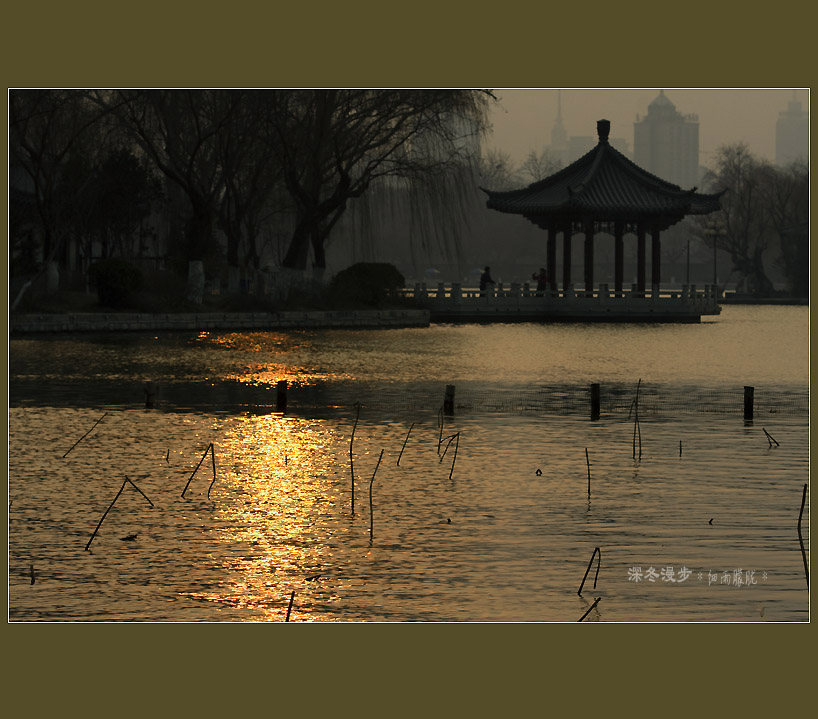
[263,89,493,270]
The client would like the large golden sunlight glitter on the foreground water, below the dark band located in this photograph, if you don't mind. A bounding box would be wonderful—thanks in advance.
[190,414,347,621]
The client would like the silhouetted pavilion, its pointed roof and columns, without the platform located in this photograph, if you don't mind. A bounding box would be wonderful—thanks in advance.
[484,120,720,294]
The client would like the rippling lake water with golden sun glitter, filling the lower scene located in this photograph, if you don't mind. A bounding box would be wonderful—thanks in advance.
[9,306,809,622]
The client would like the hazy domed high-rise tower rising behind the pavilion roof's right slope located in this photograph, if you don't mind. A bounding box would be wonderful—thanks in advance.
[633,90,699,189]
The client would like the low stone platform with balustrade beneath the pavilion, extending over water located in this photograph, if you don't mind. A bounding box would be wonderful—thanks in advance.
[405,284,721,323]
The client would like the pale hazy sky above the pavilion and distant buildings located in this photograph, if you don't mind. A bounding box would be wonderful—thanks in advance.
[485,88,809,166]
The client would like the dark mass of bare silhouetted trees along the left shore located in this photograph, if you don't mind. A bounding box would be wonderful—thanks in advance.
[9,89,493,298]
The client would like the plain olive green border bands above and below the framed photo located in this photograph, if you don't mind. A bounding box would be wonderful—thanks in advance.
[2,0,814,717]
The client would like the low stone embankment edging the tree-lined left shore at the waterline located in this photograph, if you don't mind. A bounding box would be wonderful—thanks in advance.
[9,309,429,333]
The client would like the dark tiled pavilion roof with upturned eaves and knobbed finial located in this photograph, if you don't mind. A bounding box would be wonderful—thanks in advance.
[480,120,724,224]
